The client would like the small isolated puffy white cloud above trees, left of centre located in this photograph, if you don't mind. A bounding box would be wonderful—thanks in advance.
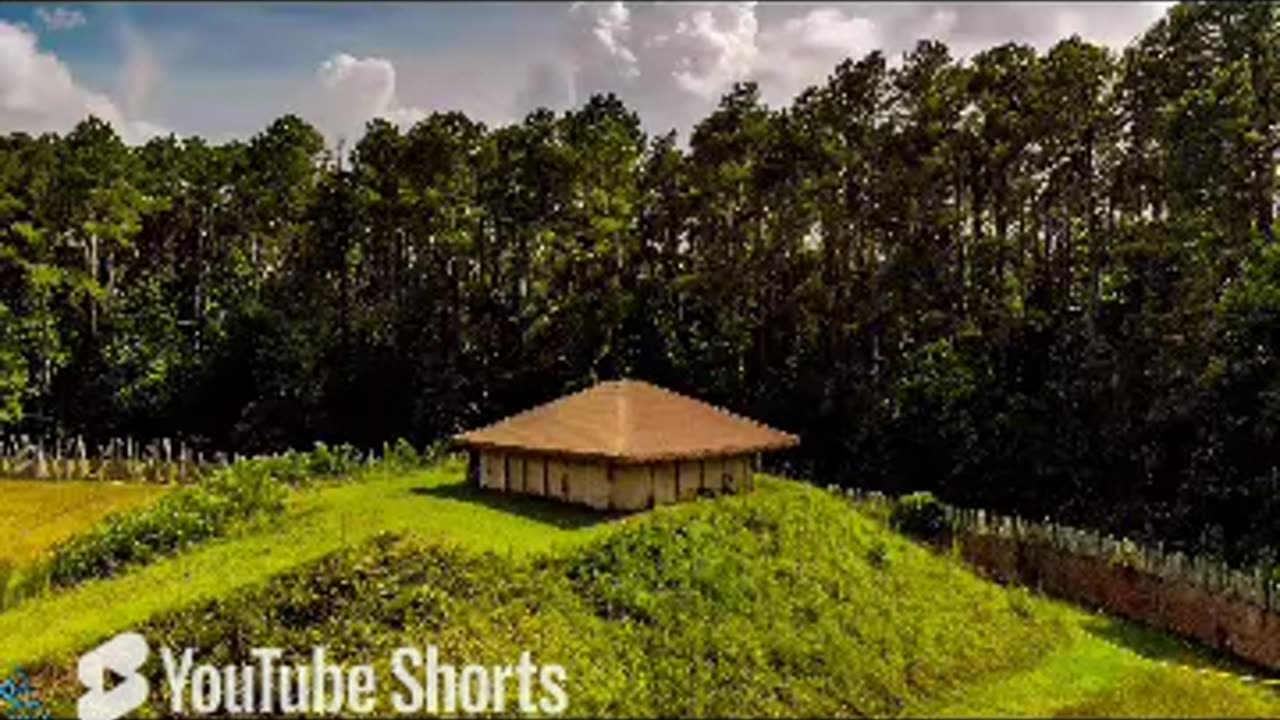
[302,53,426,146]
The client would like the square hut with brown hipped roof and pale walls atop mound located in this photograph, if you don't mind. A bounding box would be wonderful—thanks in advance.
[454,380,800,510]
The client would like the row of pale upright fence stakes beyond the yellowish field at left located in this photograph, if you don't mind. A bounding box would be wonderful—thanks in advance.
[0,433,227,483]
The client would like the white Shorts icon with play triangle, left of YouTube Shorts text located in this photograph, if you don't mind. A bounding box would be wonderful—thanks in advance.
[76,633,151,720]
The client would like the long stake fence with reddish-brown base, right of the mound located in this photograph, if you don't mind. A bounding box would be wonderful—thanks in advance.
[828,486,1280,670]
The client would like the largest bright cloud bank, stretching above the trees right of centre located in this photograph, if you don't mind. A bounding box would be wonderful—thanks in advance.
[535,1,1171,132]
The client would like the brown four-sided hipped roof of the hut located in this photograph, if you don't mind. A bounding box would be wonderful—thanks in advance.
[454,380,800,462]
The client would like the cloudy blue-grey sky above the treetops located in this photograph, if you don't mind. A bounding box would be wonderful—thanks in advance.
[0,1,1171,143]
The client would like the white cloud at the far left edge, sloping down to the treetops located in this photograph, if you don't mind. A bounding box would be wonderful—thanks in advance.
[0,20,163,142]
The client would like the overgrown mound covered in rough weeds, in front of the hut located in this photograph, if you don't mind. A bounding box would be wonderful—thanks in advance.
[27,483,1073,716]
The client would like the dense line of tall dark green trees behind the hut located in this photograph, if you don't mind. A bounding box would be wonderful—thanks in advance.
[0,4,1280,559]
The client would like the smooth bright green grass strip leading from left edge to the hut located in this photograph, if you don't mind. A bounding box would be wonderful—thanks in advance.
[0,456,619,671]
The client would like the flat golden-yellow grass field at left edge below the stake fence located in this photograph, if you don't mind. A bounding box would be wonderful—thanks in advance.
[0,479,170,565]
